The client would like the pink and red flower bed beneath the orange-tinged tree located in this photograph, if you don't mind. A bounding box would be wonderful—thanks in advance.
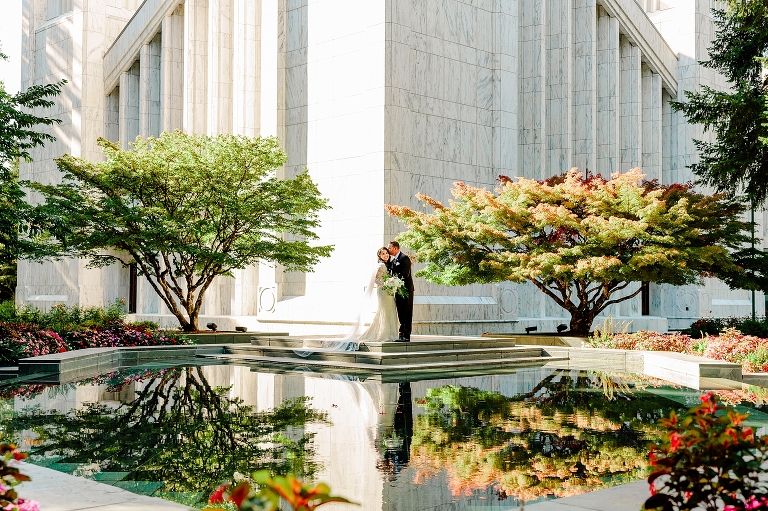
[585,328,768,373]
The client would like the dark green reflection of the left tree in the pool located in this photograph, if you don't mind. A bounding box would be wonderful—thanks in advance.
[7,368,327,504]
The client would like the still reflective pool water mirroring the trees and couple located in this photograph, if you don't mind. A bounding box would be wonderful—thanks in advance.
[0,365,748,511]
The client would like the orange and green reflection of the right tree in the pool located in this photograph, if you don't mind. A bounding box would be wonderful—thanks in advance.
[411,371,674,500]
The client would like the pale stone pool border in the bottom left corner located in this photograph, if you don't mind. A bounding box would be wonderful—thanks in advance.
[16,463,190,511]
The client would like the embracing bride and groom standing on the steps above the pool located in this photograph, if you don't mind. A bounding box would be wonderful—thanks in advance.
[359,241,413,342]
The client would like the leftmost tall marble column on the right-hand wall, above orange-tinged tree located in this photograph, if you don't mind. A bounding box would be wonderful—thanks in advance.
[518,0,549,179]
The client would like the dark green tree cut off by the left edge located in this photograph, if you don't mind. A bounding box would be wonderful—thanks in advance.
[0,46,66,302]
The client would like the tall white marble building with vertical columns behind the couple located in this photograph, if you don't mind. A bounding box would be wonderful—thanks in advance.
[17,0,766,333]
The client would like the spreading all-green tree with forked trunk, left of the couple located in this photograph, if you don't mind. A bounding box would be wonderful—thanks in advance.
[27,131,333,331]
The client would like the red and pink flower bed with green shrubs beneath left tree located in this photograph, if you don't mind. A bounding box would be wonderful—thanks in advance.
[0,302,189,365]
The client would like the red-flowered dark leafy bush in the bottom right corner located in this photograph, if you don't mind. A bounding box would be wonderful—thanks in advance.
[645,393,768,511]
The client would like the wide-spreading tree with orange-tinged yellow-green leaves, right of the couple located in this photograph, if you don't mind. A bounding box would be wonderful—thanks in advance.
[387,169,748,335]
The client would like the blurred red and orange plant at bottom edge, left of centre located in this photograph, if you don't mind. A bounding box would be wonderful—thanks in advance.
[205,470,353,511]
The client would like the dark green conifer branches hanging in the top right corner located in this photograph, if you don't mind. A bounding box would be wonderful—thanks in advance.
[672,0,768,204]
